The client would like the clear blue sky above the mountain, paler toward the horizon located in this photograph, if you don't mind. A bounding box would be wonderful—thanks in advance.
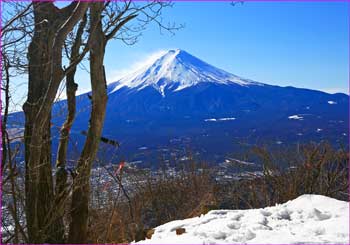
[4,1,349,110]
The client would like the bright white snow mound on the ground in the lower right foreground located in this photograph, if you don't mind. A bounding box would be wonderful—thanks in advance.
[138,195,349,244]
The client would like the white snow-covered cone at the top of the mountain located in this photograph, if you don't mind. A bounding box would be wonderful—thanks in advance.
[110,49,262,97]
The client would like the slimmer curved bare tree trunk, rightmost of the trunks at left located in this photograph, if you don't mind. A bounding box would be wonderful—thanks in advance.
[68,2,107,243]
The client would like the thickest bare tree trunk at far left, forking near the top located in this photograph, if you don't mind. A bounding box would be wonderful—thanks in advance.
[23,2,88,243]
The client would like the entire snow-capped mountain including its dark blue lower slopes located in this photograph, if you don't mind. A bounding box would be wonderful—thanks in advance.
[8,49,349,165]
